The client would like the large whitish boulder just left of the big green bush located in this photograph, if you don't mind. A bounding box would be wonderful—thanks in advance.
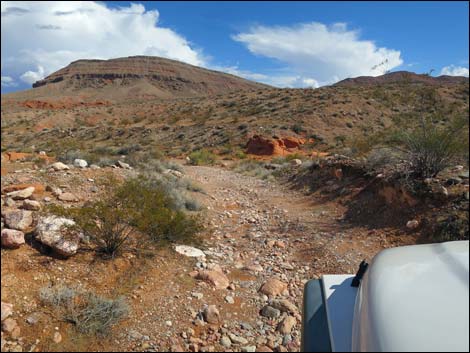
[36,216,81,257]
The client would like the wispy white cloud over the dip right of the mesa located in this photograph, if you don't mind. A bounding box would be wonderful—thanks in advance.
[232,22,403,86]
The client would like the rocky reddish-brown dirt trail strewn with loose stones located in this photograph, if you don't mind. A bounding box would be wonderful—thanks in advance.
[2,163,414,352]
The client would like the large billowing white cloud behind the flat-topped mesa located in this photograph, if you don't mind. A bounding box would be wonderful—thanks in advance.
[1,1,206,83]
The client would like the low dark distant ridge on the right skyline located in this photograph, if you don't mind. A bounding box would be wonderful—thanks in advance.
[335,71,468,86]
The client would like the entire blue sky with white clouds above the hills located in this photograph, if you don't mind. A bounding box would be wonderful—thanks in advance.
[1,1,469,92]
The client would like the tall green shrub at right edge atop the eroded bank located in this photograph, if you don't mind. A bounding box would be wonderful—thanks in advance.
[389,117,468,178]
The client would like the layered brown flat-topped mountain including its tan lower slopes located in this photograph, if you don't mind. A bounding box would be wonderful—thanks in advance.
[4,56,269,100]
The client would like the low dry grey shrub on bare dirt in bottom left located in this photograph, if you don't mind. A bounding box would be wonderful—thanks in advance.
[39,285,129,335]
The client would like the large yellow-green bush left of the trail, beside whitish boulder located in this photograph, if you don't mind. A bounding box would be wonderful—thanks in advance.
[48,176,202,257]
